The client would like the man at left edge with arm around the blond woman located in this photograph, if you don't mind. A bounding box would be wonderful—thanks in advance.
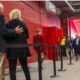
[0,3,23,80]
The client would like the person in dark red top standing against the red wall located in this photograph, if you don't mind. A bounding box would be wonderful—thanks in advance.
[33,28,45,63]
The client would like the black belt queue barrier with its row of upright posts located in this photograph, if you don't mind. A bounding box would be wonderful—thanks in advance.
[0,43,72,80]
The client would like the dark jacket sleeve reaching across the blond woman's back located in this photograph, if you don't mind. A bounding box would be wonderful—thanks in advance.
[0,25,16,36]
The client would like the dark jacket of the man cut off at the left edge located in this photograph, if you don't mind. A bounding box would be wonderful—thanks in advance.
[0,15,16,52]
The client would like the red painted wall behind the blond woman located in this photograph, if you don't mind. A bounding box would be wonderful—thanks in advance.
[2,1,60,66]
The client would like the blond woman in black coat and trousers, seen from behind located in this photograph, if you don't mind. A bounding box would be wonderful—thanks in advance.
[7,9,31,80]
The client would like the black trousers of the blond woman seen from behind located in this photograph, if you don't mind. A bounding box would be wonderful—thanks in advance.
[9,58,31,80]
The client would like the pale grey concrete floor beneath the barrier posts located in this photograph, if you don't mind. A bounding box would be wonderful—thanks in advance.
[5,59,80,80]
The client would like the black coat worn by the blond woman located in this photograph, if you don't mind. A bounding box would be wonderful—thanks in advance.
[7,19,30,59]
